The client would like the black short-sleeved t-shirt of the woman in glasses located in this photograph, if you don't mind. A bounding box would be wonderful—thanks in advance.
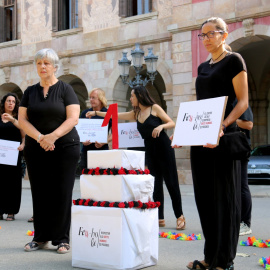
[196,52,247,118]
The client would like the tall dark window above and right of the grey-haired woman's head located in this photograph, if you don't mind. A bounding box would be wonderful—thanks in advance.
[52,0,78,32]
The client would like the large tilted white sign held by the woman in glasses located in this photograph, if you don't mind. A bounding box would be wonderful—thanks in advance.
[172,96,227,146]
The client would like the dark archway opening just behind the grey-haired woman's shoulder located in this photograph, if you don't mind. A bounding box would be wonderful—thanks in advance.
[58,74,89,111]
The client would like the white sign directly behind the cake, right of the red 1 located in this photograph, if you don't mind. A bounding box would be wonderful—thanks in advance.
[118,122,144,148]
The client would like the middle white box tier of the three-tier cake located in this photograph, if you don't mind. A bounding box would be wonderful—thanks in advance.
[80,174,154,202]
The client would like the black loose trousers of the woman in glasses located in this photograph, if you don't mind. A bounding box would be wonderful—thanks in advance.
[191,146,241,268]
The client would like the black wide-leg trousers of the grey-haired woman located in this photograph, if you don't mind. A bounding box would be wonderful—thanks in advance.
[24,139,80,245]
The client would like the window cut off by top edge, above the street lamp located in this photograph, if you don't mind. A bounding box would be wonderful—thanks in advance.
[119,0,152,18]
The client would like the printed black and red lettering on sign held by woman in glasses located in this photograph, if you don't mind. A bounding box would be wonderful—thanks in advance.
[183,112,213,130]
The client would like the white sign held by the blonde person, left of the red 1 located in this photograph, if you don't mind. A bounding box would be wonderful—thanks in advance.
[76,118,108,143]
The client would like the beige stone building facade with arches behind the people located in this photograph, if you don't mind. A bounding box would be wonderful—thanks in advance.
[0,0,270,183]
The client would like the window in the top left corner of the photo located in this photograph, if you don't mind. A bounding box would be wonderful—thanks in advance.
[0,0,17,42]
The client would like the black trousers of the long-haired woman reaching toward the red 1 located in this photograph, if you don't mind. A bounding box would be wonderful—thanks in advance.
[145,133,183,219]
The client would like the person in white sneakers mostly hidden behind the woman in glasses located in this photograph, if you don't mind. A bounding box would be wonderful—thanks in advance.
[236,107,253,235]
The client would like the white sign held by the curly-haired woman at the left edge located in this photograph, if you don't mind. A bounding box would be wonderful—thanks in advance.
[0,140,20,166]
